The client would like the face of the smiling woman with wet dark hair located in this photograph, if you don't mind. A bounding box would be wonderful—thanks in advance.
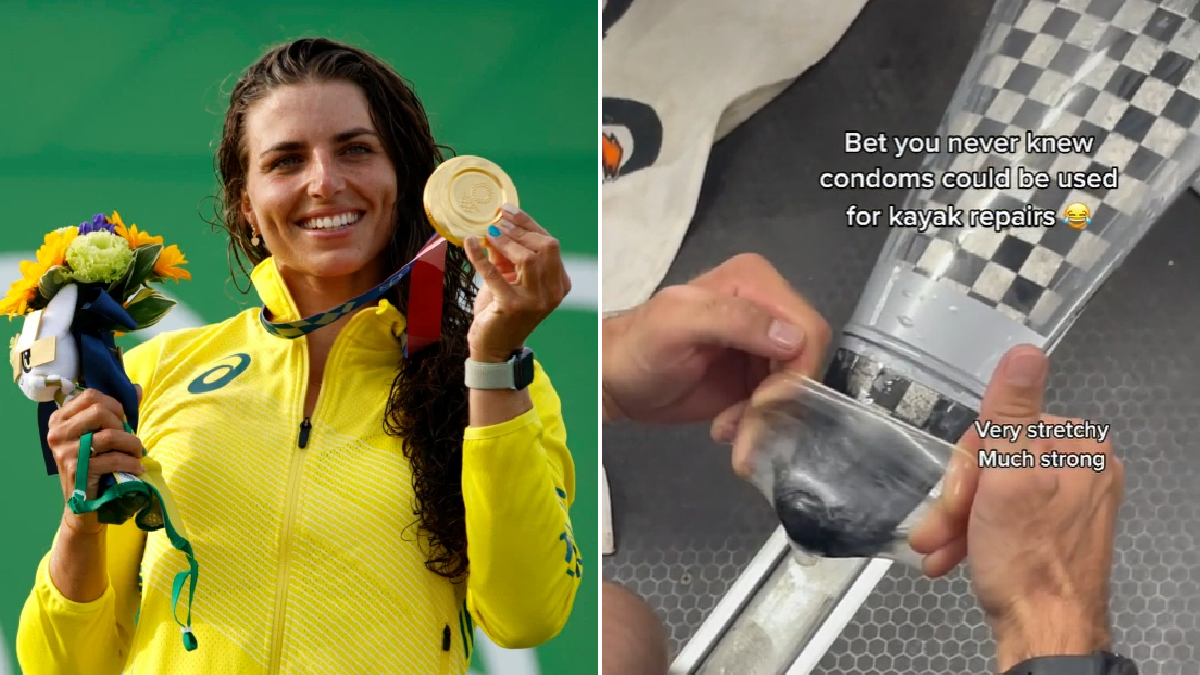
[234,80,398,316]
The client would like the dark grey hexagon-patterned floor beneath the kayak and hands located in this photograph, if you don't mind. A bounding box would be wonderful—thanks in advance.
[604,0,1200,675]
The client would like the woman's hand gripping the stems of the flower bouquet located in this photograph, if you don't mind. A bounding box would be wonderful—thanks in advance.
[46,386,144,533]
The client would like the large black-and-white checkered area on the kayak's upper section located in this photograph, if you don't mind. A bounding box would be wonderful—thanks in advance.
[900,0,1200,334]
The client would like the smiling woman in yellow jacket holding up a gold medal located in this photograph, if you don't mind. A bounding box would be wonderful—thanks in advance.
[17,38,582,675]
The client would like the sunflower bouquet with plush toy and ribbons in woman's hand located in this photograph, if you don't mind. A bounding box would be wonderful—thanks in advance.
[0,211,199,651]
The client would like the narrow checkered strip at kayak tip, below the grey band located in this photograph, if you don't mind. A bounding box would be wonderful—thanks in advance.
[824,348,978,443]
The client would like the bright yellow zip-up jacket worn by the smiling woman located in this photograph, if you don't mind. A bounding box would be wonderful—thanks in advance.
[16,254,582,675]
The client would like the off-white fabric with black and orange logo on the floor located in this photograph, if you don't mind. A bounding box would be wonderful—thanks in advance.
[601,0,866,312]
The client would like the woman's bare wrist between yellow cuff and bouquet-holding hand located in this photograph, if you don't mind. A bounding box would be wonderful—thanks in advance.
[49,509,108,603]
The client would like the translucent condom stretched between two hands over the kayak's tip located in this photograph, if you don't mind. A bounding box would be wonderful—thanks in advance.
[743,376,955,567]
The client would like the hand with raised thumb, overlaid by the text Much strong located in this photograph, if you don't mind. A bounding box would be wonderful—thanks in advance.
[910,345,1124,673]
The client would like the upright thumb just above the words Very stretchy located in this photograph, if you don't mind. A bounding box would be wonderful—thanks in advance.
[979,345,1049,425]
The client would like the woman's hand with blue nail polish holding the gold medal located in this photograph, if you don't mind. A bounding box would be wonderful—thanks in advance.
[464,204,571,363]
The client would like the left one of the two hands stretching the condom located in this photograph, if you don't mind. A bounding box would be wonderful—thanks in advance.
[602,255,830,442]
